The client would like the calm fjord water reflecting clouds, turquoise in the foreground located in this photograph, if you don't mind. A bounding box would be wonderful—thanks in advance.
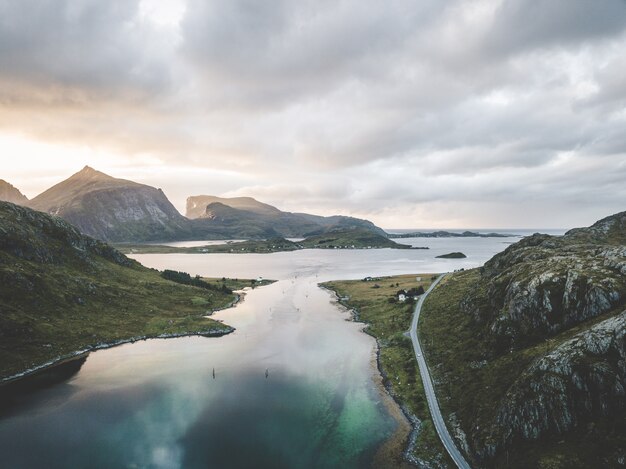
[0,238,516,468]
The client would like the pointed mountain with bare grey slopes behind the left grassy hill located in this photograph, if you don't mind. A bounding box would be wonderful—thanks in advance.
[27,166,192,242]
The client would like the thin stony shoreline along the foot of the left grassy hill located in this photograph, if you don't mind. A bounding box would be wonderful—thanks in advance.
[0,290,245,388]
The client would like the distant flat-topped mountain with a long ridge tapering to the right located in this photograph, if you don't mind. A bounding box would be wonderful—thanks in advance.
[187,195,386,238]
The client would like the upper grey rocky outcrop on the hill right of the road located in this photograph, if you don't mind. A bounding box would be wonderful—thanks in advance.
[464,230,626,348]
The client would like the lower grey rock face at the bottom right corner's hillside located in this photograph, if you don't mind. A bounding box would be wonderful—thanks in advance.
[484,311,626,456]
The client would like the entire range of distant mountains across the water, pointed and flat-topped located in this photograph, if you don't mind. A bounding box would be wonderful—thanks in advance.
[0,166,386,243]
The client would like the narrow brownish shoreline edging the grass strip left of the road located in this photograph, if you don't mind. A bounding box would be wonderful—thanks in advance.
[318,284,422,467]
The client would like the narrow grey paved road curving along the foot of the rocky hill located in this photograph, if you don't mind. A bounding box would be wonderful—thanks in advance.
[410,274,470,469]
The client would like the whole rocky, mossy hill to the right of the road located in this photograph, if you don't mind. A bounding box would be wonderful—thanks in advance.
[420,212,626,468]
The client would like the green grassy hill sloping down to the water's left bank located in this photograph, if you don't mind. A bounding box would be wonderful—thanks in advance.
[0,202,235,379]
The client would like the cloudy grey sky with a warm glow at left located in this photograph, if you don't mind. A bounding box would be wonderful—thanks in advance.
[0,0,626,228]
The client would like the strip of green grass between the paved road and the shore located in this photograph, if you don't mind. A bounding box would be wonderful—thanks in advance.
[322,274,454,467]
